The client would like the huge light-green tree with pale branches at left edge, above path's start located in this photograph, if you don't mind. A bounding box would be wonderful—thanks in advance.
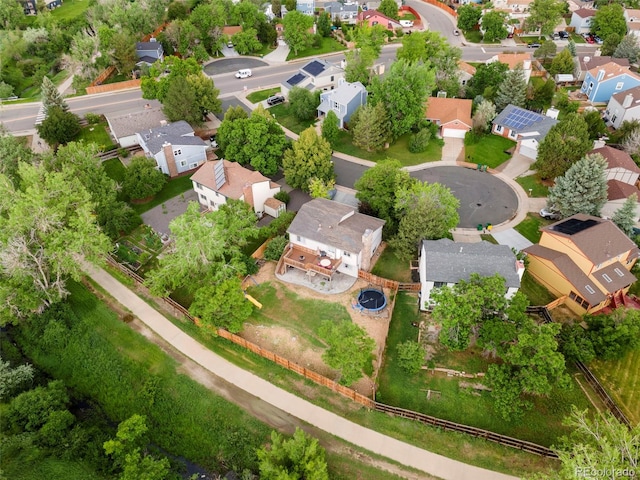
[0,164,110,324]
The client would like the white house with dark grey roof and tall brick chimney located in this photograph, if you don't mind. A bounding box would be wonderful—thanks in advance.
[136,120,207,177]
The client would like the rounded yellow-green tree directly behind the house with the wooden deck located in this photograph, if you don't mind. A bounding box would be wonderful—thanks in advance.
[282,127,335,191]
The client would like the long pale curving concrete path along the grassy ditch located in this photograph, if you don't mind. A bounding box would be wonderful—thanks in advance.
[84,264,517,480]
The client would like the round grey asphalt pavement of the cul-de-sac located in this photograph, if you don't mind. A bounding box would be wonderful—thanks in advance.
[411,166,518,228]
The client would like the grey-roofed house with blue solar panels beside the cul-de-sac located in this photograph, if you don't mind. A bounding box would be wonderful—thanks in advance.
[491,104,558,160]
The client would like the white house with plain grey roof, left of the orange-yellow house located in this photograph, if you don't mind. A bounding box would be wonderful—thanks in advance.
[418,238,524,310]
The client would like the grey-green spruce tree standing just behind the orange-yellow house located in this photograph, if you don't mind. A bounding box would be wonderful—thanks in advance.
[548,153,607,217]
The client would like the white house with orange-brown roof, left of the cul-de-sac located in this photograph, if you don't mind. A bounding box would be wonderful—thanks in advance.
[191,159,286,217]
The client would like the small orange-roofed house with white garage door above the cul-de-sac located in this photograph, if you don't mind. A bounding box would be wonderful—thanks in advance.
[425,97,473,138]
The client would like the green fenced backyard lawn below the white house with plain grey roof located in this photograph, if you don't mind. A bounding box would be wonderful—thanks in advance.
[378,292,589,446]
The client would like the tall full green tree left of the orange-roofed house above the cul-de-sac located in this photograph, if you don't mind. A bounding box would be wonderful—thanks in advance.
[371,60,435,139]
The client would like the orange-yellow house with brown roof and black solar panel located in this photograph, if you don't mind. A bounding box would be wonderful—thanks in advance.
[523,214,640,315]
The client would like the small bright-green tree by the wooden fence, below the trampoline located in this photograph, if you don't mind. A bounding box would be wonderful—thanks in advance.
[319,320,376,385]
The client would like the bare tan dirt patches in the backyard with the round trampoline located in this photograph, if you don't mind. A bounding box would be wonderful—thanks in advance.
[240,262,391,397]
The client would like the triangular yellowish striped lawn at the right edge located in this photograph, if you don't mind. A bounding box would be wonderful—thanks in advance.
[589,350,640,425]
